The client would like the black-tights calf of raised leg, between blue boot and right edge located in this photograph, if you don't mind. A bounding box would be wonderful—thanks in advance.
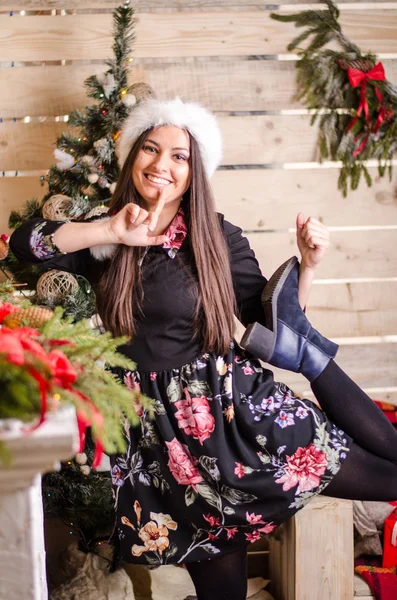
[311,360,397,462]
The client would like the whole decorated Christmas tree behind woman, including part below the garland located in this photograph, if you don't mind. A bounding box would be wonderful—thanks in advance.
[0,0,152,552]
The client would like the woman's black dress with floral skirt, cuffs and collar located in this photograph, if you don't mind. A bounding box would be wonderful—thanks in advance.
[10,213,351,566]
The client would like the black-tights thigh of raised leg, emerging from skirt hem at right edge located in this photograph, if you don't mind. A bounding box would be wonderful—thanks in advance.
[322,442,397,501]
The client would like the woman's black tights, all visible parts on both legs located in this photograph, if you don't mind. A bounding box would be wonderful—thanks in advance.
[186,360,397,600]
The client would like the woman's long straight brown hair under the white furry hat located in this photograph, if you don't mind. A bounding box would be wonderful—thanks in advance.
[97,130,235,354]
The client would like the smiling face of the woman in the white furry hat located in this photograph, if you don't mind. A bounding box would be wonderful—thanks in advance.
[132,125,191,206]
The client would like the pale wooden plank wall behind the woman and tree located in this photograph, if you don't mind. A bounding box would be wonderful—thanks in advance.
[0,0,397,403]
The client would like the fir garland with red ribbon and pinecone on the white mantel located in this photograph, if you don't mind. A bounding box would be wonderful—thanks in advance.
[0,283,152,467]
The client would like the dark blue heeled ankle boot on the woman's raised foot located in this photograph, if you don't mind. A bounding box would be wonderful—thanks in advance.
[240,256,338,382]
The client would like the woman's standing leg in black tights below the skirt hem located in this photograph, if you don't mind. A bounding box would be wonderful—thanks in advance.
[186,546,247,600]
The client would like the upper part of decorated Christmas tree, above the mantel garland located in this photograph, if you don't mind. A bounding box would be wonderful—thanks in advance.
[0,0,152,320]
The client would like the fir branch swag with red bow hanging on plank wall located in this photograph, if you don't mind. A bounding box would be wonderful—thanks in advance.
[270,0,397,196]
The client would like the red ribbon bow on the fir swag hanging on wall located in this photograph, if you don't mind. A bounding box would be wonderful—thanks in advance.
[347,62,386,157]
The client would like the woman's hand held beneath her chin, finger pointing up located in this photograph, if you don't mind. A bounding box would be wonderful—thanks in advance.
[107,194,168,246]
